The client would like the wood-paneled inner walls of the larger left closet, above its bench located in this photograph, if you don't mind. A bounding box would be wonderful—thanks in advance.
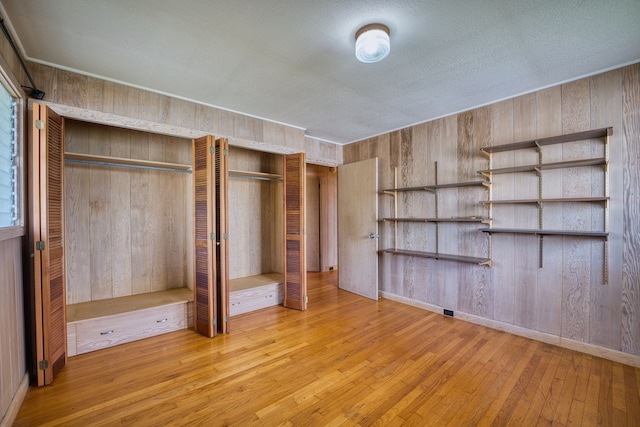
[64,120,193,304]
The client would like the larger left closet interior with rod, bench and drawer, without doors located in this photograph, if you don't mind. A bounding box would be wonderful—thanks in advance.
[63,120,193,356]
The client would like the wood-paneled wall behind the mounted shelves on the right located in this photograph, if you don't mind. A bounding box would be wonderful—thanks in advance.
[344,64,640,362]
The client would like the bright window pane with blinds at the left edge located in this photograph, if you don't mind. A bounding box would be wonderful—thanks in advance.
[0,84,20,227]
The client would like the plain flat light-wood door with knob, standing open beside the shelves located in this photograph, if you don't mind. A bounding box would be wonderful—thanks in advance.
[338,158,378,300]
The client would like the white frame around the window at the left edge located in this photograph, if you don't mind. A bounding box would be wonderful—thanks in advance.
[0,57,26,241]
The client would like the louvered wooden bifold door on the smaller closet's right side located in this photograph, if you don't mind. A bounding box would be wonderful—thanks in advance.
[284,153,307,310]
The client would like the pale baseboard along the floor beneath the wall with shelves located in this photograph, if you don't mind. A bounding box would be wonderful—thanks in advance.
[379,291,640,368]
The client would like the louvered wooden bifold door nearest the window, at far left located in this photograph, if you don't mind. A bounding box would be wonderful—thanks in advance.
[30,103,67,385]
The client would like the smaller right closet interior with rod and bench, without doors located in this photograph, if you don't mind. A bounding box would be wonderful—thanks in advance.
[228,147,284,316]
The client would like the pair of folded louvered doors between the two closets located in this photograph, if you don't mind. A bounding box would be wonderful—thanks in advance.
[192,135,229,337]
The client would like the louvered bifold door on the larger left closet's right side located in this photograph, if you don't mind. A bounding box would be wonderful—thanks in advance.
[192,136,217,337]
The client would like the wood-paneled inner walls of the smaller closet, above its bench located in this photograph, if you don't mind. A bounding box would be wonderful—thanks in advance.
[229,147,284,279]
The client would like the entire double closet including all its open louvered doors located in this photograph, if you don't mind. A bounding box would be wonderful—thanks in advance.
[29,103,307,385]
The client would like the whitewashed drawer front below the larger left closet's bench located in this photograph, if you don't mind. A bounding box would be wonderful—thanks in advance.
[75,304,188,354]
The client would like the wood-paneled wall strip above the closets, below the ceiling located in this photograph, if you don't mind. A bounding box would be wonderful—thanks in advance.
[29,63,342,165]
